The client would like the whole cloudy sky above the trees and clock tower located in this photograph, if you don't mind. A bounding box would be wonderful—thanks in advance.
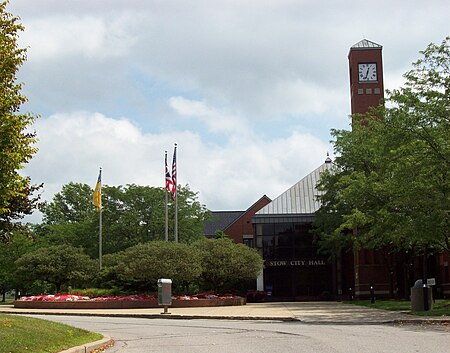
[8,0,450,220]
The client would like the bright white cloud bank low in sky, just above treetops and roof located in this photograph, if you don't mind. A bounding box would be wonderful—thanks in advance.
[25,112,327,214]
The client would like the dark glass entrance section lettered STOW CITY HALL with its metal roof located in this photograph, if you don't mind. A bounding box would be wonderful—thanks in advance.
[252,158,333,300]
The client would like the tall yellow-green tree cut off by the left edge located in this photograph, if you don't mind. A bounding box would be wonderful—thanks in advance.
[0,1,37,240]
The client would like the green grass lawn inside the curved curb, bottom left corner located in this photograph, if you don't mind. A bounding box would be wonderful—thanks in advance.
[0,314,103,353]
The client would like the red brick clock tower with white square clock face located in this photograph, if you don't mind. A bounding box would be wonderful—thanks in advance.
[348,39,384,115]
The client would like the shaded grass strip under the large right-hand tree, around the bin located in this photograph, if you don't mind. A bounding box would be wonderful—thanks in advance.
[346,299,450,316]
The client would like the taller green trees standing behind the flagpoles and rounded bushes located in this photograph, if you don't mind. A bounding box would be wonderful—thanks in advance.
[35,183,207,257]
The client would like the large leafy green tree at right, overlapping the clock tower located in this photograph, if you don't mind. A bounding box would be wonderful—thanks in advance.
[316,37,450,254]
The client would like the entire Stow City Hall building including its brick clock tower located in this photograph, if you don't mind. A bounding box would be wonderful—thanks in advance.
[205,39,450,300]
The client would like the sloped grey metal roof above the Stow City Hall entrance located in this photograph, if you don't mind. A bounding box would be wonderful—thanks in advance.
[255,158,332,217]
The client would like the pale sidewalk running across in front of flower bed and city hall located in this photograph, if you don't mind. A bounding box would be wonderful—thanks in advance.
[0,302,450,325]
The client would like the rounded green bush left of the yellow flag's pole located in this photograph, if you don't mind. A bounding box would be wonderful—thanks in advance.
[16,245,97,292]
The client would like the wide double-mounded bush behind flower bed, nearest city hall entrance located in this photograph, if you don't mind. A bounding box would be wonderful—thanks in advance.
[89,237,263,294]
